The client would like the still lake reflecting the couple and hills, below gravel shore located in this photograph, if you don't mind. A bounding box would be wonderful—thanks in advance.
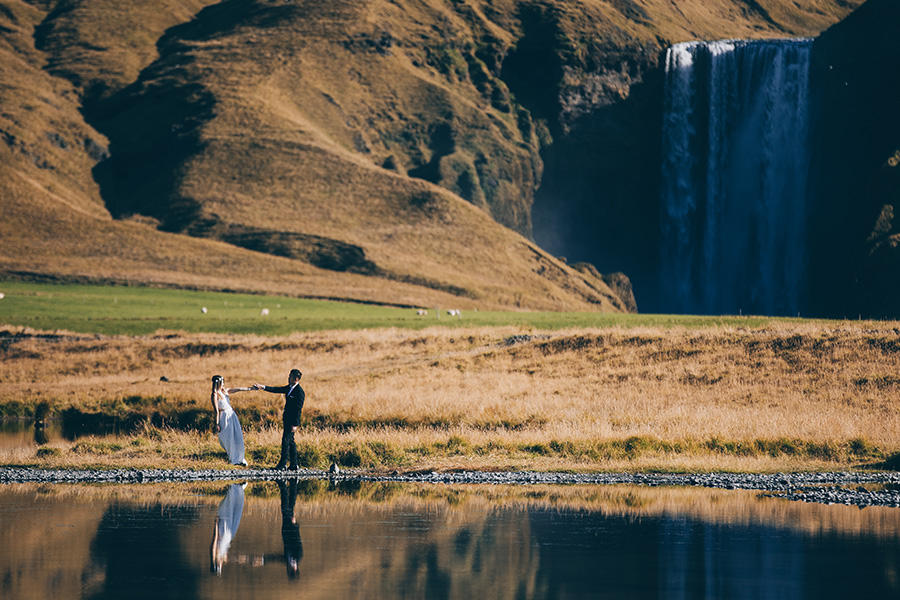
[0,479,900,600]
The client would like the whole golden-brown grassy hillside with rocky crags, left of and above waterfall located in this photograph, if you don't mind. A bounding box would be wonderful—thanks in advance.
[0,0,858,311]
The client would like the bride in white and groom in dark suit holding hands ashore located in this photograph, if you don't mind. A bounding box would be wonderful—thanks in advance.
[210,369,306,471]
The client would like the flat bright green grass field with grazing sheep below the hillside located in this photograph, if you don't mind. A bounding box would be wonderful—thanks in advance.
[0,281,808,336]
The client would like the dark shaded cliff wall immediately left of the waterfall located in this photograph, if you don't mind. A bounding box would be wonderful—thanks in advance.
[532,45,663,312]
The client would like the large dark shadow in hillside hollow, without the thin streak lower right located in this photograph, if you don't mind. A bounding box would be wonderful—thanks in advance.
[83,0,300,232]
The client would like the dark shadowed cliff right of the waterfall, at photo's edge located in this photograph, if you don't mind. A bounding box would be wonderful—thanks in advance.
[810,0,900,318]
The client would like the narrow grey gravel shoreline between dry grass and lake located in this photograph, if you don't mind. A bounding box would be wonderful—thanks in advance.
[0,467,900,508]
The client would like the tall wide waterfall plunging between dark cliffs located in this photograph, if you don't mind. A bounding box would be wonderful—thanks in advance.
[661,39,812,315]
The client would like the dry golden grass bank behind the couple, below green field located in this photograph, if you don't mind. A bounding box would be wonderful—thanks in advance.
[0,322,900,471]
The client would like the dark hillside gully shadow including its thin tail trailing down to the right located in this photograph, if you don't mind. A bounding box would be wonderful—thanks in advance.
[84,0,378,275]
